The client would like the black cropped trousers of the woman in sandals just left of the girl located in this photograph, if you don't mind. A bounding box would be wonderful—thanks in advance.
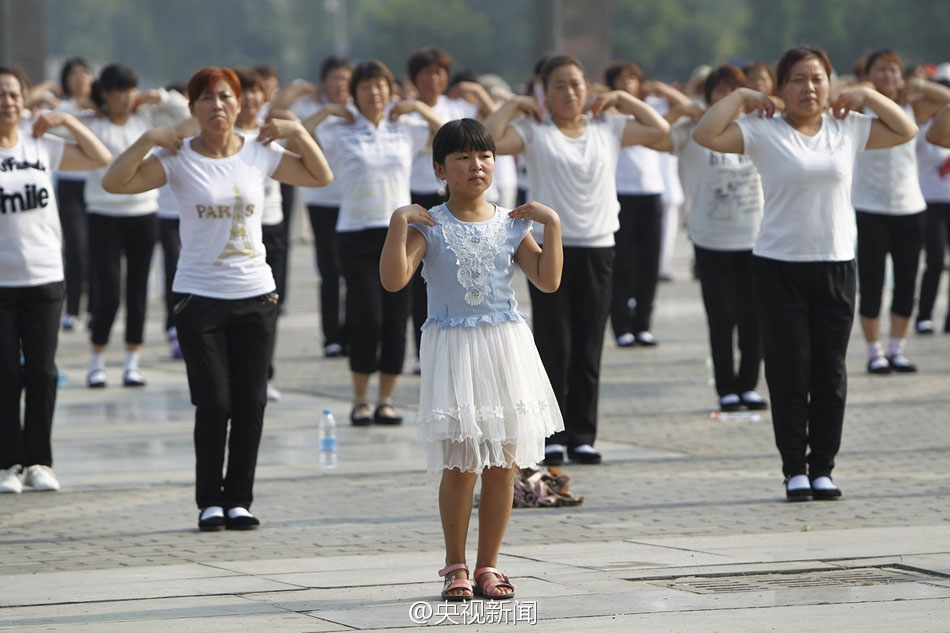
[339,229,410,374]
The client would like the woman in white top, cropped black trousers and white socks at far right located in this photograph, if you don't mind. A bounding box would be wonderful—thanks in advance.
[851,49,950,374]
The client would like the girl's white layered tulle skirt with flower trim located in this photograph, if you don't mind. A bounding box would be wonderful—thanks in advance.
[418,322,564,473]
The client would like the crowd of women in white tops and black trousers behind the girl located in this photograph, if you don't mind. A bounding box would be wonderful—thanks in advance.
[0,46,950,530]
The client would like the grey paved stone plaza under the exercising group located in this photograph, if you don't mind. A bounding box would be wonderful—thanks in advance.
[0,230,950,633]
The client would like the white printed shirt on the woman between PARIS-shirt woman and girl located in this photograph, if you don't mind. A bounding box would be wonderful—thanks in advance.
[316,105,430,233]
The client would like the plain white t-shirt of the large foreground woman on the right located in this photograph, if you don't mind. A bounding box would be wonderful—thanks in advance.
[736,112,871,262]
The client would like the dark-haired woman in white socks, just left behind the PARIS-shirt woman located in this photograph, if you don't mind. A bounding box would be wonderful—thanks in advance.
[83,64,188,388]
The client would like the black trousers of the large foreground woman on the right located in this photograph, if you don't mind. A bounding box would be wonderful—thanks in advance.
[753,257,855,479]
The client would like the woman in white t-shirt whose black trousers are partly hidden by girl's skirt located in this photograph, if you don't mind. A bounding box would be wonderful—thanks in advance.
[485,55,669,464]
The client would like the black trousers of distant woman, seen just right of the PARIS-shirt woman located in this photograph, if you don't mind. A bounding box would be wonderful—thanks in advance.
[307,204,346,347]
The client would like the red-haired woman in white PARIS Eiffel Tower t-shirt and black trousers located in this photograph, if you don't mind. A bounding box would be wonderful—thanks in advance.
[102,68,333,531]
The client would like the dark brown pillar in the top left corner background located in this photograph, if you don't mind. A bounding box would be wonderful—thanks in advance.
[0,0,46,83]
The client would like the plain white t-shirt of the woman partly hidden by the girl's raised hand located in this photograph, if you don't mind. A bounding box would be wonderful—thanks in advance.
[511,114,627,248]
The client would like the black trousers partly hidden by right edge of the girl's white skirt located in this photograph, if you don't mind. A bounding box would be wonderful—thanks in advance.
[528,246,614,448]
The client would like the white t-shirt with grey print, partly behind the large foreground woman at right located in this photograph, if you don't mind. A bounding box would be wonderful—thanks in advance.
[670,119,763,251]
